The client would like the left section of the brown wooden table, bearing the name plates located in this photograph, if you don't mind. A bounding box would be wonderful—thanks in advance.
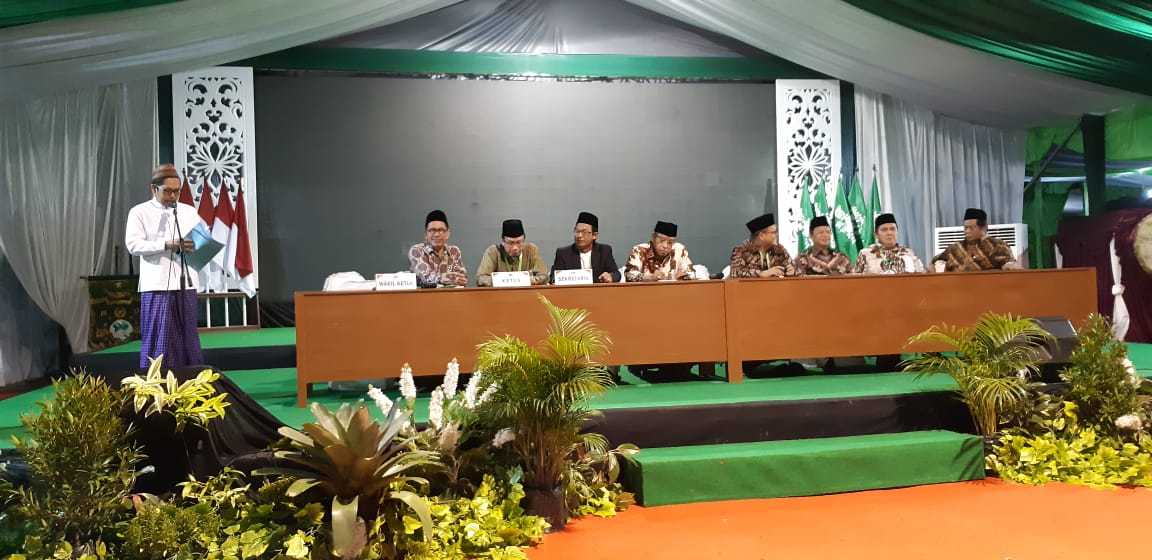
[296,281,727,407]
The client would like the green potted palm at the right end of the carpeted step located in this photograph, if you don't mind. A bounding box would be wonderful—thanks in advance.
[903,312,1054,444]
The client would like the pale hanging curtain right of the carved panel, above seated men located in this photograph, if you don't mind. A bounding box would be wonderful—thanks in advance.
[856,88,1028,258]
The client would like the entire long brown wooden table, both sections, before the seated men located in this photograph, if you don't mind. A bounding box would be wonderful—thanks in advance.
[296,268,1096,407]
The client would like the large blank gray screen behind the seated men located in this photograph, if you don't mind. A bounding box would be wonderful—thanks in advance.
[256,75,775,302]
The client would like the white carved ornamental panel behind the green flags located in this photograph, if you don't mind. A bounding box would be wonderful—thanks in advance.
[776,80,841,255]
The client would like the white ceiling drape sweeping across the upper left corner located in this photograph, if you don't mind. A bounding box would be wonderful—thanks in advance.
[0,0,456,99]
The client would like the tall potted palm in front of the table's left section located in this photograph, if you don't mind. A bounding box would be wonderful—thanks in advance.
[477,296,612,530]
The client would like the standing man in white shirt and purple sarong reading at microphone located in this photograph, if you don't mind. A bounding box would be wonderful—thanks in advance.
[124,164,212,368]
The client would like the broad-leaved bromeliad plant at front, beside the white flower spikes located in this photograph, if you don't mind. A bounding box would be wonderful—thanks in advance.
[258,402,437,559]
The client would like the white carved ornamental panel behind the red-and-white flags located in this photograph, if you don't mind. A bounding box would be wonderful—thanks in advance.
[172,67,259,290]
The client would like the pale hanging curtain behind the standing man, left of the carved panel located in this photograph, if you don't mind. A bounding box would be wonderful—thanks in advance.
[0,80,156,351]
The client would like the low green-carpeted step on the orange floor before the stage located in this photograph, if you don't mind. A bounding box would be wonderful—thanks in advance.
[626,431,984,506]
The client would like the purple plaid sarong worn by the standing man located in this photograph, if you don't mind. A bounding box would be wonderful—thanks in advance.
[141,289,204,370]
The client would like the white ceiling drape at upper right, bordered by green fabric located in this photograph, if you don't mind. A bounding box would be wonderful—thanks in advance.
[628,0,1146,128]
